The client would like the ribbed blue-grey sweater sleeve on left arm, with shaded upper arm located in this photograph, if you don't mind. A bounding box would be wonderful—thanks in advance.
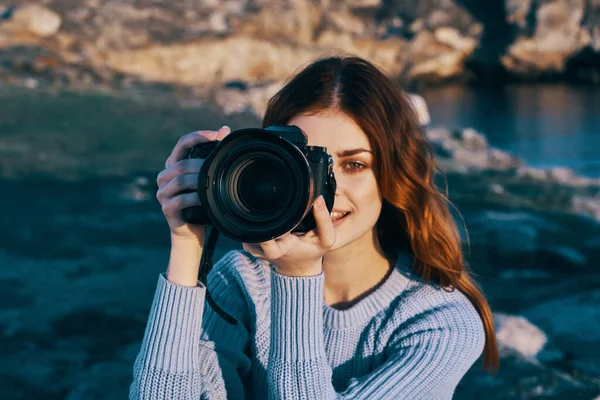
[129,255,251,399]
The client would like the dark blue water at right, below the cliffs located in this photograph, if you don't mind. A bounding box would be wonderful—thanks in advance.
[421,84,600,176]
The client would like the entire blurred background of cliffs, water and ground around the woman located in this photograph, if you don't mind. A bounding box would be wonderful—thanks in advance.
[0,0,600,400]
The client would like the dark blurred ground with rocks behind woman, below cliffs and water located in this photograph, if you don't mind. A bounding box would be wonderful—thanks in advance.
[0,87,600,400]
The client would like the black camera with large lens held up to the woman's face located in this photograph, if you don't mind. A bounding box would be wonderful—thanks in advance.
[182,125,336,243]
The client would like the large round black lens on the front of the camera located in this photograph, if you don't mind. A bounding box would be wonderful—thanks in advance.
[199,129,313,243]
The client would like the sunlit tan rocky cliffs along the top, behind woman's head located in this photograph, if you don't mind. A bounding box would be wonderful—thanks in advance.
[0,0,600,94]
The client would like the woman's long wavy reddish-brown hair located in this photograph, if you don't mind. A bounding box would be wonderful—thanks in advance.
[262,55,498,371]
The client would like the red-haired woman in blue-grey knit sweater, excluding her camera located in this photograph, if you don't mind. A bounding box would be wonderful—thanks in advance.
[131,57,498,399]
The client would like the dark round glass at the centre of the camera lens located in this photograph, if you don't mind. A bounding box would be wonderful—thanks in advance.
[233,154,289,213]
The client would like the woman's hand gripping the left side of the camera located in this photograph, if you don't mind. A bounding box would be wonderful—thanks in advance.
[156,126,231,247]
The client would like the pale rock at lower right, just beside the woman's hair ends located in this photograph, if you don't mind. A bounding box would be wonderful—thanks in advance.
[494,313,548,358]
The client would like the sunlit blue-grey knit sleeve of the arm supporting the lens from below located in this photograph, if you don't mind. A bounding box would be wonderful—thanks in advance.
[268,272,485,400]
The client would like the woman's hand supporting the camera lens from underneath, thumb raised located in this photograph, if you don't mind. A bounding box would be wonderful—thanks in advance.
[243,196,336,276]
